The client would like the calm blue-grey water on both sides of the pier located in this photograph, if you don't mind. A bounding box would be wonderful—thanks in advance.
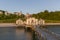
[0,25,60,40]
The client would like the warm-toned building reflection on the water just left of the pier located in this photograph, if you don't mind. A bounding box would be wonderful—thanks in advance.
[16,29,32,40]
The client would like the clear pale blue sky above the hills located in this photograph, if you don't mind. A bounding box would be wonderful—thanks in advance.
[0,0,60,14]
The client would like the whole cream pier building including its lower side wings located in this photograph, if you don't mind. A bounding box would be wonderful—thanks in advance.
[16,17,45,25]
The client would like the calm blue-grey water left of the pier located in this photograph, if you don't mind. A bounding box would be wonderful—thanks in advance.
[0,27,32,40]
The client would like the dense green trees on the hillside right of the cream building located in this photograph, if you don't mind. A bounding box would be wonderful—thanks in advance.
[32,10,60,20]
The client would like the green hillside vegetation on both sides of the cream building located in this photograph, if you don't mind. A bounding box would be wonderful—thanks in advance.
[0,10,60,23]
